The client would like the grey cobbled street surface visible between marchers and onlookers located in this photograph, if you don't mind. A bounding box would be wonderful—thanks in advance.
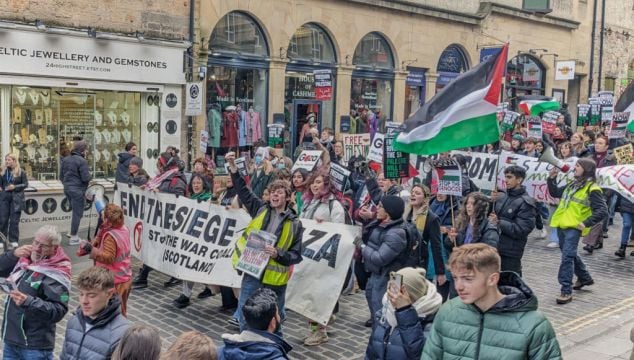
[1,225,634,360]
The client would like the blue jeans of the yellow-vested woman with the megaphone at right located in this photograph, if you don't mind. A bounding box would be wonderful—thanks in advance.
[557,229,592,295]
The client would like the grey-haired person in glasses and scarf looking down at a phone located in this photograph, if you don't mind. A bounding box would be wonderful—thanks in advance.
[0,225,71,359]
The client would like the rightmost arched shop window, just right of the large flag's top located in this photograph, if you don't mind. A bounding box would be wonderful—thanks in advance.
[506,54,546,97]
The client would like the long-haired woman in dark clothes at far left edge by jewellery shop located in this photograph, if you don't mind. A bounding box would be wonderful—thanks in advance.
[0,154,29,248]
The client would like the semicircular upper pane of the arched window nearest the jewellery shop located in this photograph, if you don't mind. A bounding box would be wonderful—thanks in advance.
[209,11,269,57]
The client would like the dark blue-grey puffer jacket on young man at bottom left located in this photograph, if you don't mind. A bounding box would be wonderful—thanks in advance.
[59,295,130,360]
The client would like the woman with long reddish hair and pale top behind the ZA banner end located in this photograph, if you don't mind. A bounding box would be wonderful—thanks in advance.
[300,168,346,346]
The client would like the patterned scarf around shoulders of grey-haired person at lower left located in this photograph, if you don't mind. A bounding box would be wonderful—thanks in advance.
[8,246,71,291]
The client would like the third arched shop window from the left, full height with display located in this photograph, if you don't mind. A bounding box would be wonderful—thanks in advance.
[350,33,394,133]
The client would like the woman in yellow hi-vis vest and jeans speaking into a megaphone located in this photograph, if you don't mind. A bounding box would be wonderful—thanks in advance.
[547,158,608,304]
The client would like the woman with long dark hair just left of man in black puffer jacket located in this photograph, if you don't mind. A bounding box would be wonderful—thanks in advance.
[445,191,500,249]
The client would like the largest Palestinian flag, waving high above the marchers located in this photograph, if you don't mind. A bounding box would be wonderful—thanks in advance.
[393,44,508,155]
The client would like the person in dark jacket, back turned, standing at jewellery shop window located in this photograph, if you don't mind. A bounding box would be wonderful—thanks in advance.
[60,140,92,245]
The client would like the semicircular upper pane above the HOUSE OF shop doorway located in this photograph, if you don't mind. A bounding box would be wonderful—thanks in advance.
[286,23,337,64]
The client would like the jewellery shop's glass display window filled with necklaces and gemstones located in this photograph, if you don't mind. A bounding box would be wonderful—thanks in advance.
[9,86,139,180]
